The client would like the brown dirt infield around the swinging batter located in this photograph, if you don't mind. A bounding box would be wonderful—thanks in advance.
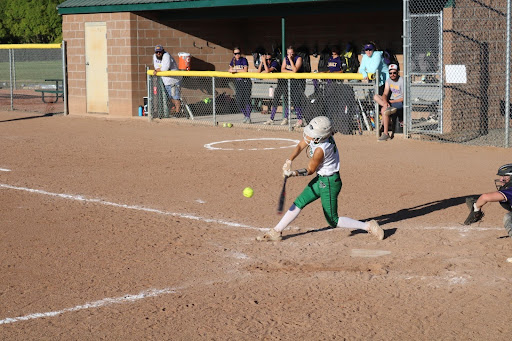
[0,112,512,340]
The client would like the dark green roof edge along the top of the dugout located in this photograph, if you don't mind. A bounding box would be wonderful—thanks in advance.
[57,0,328,14]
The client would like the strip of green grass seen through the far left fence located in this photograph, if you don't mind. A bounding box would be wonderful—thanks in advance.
[0,60,62,86]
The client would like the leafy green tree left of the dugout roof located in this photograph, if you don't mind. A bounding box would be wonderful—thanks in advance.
[0,0,64,44]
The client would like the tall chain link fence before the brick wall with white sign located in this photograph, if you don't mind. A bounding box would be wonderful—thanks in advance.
[404,0,510,147]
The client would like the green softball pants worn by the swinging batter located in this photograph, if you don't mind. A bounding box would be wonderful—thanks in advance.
[294,173,342,227]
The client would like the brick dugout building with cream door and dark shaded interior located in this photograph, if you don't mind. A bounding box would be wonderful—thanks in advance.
[58,0,403,116]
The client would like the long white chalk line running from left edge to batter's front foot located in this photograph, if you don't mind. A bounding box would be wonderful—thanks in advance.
[0,184,264,230]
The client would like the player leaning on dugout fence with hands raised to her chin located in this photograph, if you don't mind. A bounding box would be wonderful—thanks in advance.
[281,46,306,127]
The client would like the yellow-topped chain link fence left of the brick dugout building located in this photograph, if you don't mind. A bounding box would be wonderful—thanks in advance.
[0,43,66,114]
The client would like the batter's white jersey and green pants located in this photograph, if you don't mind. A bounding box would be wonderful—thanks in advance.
[294,136,342,227]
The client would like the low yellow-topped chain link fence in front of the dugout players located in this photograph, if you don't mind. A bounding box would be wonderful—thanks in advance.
[145,71,380,134]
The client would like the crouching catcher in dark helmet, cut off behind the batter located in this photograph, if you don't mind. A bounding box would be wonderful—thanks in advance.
[464,163,512,263]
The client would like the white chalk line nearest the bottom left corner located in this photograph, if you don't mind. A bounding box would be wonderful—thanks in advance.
[0,288,176,325]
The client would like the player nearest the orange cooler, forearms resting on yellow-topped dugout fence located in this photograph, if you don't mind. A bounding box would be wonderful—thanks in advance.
[229,47,252,123]
